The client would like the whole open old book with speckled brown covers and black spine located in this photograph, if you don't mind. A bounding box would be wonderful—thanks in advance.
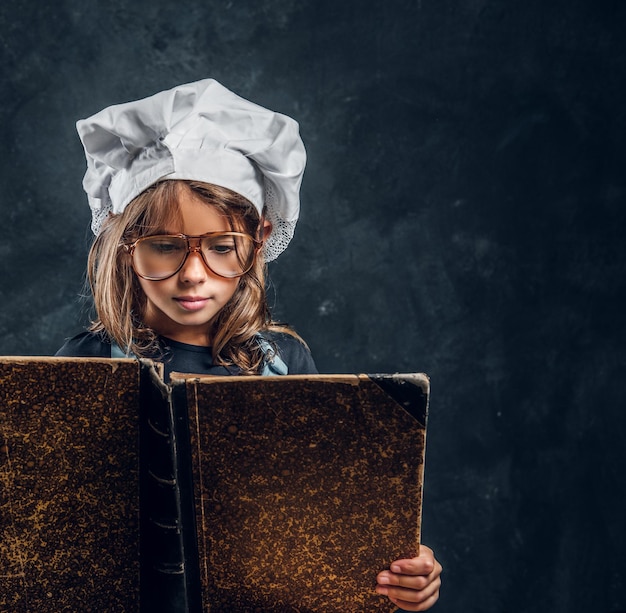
[0,358,428,613]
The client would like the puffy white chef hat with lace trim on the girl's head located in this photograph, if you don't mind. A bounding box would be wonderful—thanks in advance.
[76,79,306,261]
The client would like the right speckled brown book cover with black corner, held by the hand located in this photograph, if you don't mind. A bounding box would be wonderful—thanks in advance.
[172,375,429,613]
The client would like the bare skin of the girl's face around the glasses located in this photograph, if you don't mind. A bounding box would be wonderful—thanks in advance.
[137,189,239,346]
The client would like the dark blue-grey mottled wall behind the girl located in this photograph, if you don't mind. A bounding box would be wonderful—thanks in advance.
[0,0,626,613]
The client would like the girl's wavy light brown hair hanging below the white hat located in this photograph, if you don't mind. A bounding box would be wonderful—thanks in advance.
[87,180,301,374]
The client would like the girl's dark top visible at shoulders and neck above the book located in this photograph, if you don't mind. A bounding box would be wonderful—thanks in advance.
[56,332,317,381]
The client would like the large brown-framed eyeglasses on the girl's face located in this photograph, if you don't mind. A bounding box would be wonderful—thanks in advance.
[124,232,262,281]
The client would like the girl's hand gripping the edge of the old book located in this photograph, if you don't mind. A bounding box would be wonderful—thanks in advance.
[376,545,442,611]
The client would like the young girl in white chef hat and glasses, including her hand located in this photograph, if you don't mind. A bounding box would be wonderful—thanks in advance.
[57,79,441,611]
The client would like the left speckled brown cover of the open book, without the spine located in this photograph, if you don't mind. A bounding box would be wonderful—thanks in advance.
[0,358,139,613]
